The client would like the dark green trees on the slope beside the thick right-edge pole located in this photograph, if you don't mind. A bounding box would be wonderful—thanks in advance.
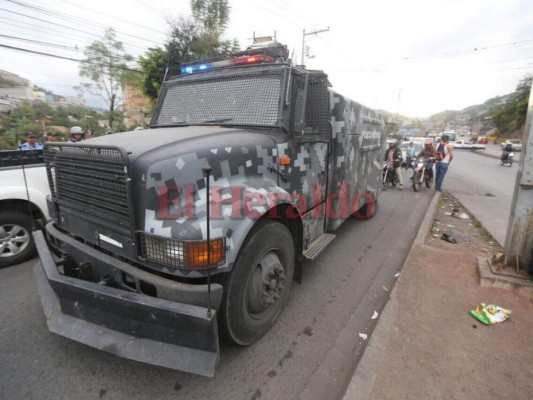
[491,75,531,136]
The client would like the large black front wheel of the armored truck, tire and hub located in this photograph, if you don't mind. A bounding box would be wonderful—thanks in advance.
[218,220,295,346]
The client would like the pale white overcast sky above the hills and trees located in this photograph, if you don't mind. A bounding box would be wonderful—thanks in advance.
[0,0,533,117]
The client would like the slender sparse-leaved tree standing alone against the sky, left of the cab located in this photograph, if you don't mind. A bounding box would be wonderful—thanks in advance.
[79,28,133,129]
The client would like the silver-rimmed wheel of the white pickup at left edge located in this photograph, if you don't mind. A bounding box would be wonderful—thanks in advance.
[0,211,35,268]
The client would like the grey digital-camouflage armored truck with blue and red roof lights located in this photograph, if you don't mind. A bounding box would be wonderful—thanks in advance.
[35,43,385,376]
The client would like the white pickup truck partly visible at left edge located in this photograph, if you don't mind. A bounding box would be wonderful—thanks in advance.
[0,150,50,268]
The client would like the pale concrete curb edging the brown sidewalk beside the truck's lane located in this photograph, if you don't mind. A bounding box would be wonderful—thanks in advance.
[342,192,440,400]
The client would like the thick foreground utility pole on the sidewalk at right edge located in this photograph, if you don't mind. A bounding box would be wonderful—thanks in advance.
[504,84,533,272]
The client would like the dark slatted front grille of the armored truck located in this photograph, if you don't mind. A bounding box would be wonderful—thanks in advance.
[44,144,131,225]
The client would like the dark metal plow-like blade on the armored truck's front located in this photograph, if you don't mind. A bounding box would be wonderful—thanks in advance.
[34,231,220,376]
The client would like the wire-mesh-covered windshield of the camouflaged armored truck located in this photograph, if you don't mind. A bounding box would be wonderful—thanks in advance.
[152,68,284,126]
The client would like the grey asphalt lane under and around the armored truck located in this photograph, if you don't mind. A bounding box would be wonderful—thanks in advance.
[0,184,433,399]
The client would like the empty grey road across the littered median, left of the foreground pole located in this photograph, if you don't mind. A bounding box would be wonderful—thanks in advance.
[443,145,520,246]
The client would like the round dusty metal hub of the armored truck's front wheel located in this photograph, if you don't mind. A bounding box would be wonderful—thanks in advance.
[247,251,286,317]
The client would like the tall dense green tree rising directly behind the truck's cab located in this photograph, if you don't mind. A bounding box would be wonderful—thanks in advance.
[137,0,239,100]
